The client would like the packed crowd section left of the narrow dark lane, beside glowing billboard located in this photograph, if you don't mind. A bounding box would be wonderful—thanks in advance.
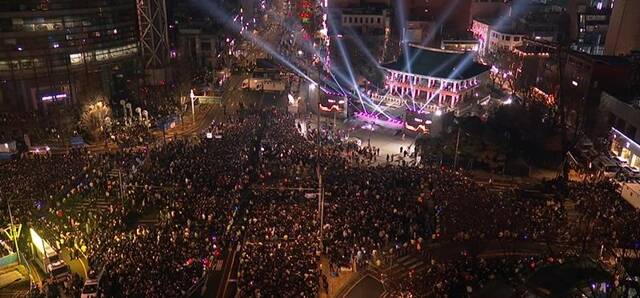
[0,111,256,297]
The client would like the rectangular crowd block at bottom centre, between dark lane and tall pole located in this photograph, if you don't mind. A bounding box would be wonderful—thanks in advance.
[238,191,319,297]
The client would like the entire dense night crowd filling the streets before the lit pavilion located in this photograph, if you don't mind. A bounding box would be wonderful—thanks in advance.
[0,104,640,297]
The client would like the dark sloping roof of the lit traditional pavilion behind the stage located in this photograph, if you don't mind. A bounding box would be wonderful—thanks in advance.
[382,46,490,80]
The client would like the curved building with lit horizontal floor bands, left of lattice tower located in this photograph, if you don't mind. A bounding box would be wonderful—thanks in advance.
[0,0,139,112]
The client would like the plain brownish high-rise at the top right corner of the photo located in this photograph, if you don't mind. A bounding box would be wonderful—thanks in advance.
[604,0,640,55]
